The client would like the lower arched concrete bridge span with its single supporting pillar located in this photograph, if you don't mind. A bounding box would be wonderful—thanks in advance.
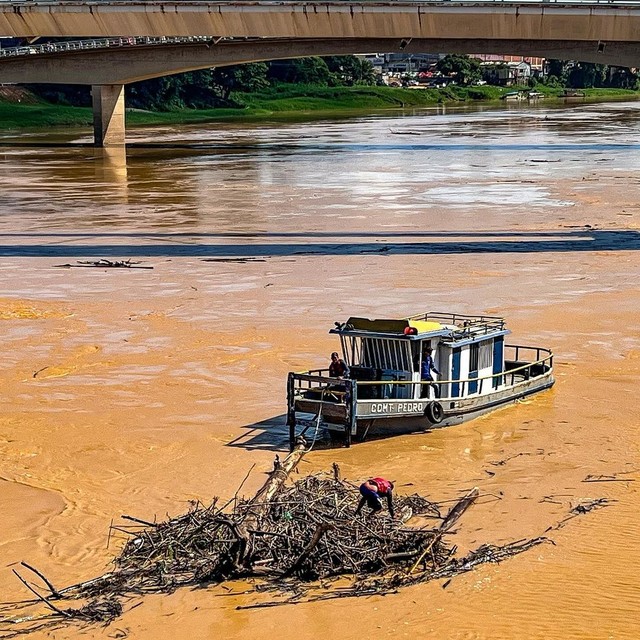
[0,38,640,146]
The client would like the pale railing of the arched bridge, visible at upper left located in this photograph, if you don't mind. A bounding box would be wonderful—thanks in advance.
[0,36,222,58]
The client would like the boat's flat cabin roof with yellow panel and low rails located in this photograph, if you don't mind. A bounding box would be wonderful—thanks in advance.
[329,311,509,342]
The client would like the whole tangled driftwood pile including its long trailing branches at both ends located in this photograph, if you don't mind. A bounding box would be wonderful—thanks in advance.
[0,456,544,634]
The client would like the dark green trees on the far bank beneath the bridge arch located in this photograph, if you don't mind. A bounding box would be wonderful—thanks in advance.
[29,54,638,111]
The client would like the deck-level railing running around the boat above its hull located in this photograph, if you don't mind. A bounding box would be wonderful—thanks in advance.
[291,345,553,400]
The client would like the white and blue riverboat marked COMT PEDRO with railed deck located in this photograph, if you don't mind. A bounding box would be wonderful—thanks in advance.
[287,312,554,447]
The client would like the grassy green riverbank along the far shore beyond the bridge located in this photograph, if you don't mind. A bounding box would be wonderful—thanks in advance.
[0,85,638,131]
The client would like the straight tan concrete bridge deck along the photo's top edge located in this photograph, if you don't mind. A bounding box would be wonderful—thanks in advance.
[0,0,640,42]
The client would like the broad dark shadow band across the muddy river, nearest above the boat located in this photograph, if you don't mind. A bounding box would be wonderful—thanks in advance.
[0,229,640,259]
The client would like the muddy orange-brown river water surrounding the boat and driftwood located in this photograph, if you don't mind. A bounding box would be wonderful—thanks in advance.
[0,103,640,640]
